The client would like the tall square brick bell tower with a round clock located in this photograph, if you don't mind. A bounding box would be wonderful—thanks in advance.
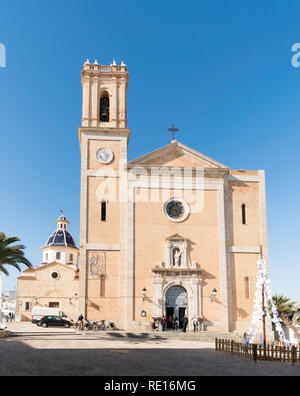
[78,60,130,326]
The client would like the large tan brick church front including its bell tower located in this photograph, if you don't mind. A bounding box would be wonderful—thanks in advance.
[78,61,268,332]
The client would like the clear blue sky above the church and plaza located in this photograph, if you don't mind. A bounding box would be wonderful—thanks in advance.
[0,0,300,301]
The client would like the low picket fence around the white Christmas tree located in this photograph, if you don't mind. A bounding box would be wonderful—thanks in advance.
[216,338,300,363]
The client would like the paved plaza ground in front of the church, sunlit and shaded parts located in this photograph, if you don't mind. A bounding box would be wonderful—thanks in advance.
[0,323,300,376]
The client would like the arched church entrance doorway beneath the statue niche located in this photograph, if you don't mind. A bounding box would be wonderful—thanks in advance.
[166,286,188,329]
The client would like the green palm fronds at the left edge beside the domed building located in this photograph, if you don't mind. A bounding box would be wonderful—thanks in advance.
[0,232,32,276]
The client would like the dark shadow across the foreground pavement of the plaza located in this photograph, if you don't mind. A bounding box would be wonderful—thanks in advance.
[0,338,300,376]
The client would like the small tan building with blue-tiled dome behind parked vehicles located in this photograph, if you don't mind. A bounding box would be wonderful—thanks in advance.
[17,214,79,321]
